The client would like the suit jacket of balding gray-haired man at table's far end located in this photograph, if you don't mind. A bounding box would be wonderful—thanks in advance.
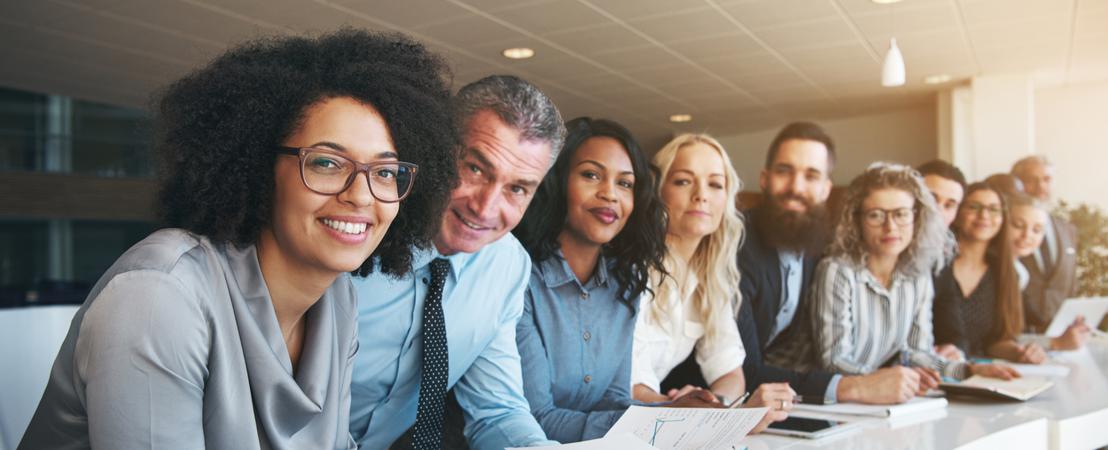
[1020,215,1077,333]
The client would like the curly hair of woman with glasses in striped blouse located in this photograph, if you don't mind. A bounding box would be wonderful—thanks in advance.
[829,162,956,276]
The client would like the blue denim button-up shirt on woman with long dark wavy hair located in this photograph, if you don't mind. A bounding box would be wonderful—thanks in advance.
[515,250,638,442]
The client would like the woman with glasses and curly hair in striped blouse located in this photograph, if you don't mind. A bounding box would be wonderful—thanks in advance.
[793,163,1018,394]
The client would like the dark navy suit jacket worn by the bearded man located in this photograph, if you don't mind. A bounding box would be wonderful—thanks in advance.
[661,208,833,396]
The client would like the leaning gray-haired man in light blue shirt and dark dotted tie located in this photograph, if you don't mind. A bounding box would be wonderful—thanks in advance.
[350,75,565,449]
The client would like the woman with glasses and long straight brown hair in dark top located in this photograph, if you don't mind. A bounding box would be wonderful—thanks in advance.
[935,183,1046,364]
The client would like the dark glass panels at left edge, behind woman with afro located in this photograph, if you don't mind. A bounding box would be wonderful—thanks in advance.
[0,88,155,307]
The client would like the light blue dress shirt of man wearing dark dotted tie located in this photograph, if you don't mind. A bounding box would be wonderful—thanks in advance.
[350,234,553,449]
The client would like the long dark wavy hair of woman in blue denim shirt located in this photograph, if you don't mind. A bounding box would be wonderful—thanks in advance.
[513,117,666,308]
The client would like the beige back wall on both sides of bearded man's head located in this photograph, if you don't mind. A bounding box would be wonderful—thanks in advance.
[716,104,938,191]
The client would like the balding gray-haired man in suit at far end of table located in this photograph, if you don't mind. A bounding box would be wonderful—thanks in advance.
[1012,155,1077,331]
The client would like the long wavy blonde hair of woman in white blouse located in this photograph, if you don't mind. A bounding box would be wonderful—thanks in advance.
[649,133,745,336]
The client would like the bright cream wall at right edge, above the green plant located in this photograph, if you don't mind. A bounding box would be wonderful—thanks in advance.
[1035,81,1108,211]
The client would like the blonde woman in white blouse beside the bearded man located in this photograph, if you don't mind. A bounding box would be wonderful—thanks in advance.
[632,134,796,429]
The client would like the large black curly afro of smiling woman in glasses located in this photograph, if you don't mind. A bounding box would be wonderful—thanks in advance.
[156,29,458,276]
